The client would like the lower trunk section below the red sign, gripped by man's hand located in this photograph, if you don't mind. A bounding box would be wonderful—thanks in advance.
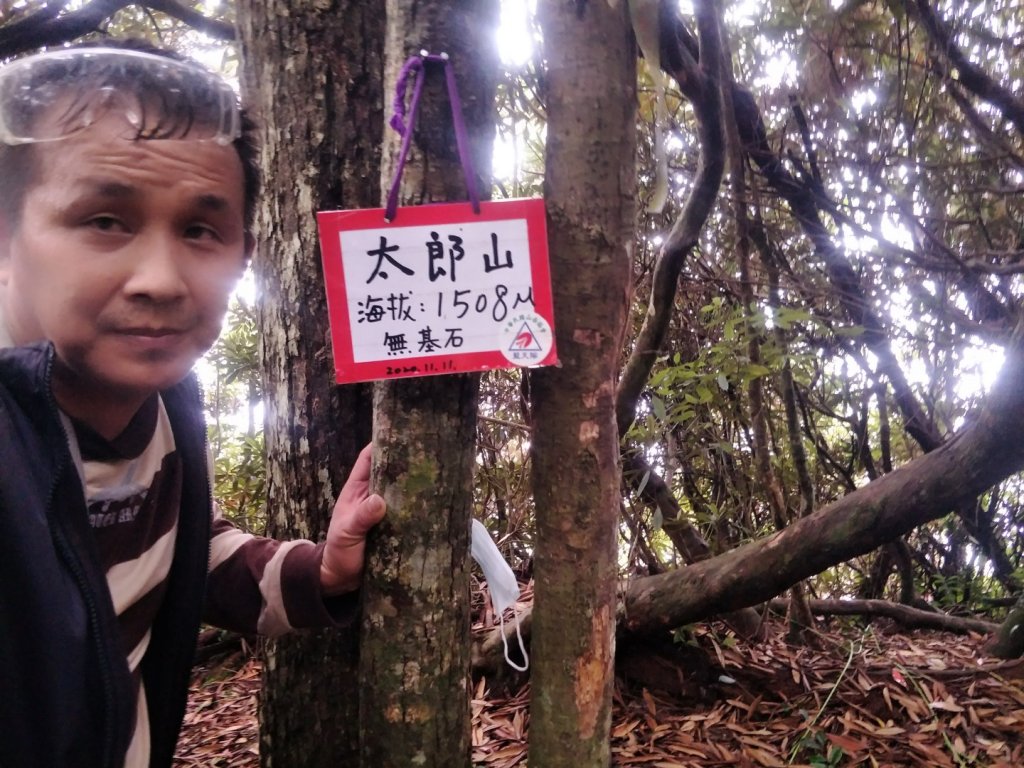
[359,375,479,768]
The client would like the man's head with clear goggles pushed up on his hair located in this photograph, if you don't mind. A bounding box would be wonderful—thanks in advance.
[0,41,256,435]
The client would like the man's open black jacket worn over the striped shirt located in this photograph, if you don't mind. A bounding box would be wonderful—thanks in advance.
[0,344,211,768]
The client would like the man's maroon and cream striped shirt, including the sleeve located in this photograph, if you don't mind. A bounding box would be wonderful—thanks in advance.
[68,395,331,768]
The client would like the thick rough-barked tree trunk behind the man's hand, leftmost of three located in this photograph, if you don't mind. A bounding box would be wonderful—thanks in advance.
[239,0,384,768]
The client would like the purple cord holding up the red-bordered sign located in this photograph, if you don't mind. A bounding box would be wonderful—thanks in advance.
[384,53,480,222]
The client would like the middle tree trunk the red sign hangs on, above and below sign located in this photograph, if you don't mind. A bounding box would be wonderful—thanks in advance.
[359,0,498,768]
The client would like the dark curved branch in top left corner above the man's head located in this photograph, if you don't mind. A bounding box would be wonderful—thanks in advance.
[0,0,234,58]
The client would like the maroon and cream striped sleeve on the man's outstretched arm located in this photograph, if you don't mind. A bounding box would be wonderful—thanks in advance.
[204,504,358,637]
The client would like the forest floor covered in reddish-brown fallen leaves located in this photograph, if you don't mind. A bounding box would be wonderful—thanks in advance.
[175,610,1024,768]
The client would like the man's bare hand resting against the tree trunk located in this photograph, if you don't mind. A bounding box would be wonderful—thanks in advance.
[321,445,385,596]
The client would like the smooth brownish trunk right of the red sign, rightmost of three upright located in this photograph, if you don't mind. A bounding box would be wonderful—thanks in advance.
[529,0,636,768]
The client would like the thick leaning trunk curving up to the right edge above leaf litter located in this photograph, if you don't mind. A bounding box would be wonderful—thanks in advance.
[621,323,1024,633]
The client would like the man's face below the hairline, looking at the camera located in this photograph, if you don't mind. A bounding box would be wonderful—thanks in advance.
[0,112,247,399]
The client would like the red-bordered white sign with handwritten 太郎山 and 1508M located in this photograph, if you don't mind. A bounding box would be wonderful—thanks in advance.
[316,200,558,383]
